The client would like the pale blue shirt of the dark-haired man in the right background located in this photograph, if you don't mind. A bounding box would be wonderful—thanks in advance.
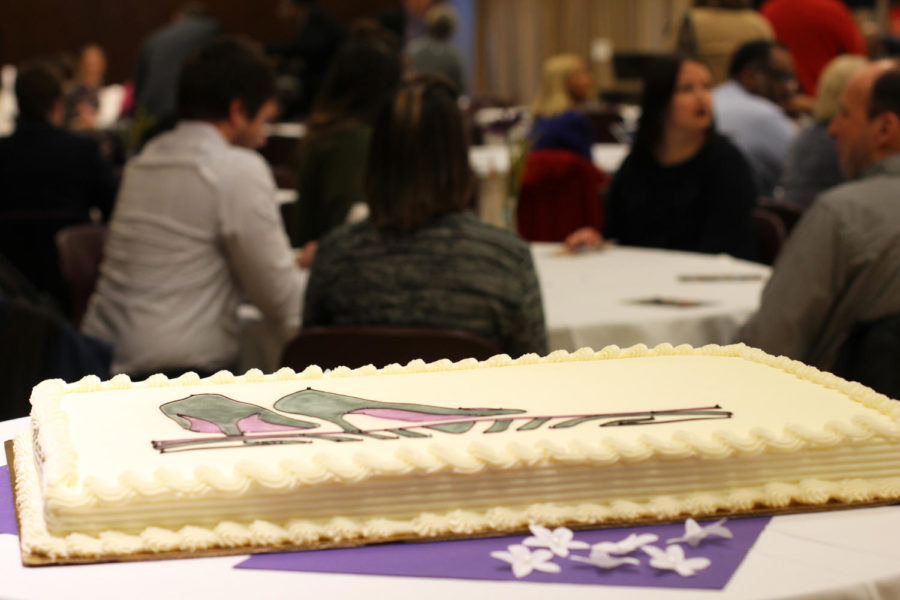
[713,79,796,197]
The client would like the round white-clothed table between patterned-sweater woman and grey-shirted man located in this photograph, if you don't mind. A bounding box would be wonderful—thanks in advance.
[532,243,771,351]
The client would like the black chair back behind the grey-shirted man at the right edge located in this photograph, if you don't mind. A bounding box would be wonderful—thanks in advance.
[832,314,900,400]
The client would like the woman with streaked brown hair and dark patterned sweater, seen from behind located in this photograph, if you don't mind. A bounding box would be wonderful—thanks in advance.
[303,77,547,356]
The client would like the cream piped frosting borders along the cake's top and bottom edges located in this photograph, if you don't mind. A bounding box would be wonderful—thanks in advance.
[15,344,900,557]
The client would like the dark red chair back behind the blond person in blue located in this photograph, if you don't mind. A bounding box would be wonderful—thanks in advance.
[516,149,608,242]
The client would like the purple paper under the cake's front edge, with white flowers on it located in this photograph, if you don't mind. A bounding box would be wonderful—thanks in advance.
[236,517,769,590]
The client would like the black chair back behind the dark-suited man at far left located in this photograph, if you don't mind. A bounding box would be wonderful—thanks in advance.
[0,210,84,312]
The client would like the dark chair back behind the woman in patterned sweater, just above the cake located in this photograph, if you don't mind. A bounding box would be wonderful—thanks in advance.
[281,326,500,373]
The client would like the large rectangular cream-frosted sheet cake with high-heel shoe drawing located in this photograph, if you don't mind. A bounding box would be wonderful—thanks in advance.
[14,346,900,562]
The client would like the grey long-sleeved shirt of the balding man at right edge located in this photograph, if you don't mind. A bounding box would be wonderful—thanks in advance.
[740,154,900,370]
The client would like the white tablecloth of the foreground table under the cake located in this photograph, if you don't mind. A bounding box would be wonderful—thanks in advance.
[0,418,900,600]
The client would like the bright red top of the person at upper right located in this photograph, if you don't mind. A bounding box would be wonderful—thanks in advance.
[759,0,865,96]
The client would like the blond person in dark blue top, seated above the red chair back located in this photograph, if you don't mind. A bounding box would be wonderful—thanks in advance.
[529,54,591,159]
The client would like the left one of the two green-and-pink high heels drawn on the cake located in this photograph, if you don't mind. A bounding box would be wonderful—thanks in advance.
[159,394,319,436]
